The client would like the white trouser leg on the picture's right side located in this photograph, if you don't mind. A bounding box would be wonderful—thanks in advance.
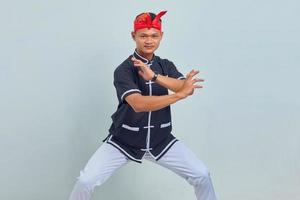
[149,141,217,200]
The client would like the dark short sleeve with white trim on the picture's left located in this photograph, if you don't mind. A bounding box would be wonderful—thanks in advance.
[114,66,141,102]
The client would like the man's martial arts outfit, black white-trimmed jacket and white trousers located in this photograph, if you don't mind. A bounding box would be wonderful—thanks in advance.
[70,51,216,200]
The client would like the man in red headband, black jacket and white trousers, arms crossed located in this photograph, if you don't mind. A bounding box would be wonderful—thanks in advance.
[70,11,216,200]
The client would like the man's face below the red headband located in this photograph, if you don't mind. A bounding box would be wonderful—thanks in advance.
[131,28,163,54]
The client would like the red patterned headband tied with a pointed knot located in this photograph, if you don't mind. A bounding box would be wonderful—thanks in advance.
[134,11,167,32]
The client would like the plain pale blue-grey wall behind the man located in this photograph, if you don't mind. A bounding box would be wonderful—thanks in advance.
[0,0,300,200]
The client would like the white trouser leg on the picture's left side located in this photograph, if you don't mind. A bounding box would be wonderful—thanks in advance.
[69,143,129,200]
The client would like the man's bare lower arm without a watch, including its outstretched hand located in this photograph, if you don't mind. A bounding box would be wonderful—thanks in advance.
[125,70,202,112]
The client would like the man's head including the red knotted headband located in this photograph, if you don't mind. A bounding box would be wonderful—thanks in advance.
[131,11,166,56]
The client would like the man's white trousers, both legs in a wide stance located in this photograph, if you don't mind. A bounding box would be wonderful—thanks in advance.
[70,141,217,200]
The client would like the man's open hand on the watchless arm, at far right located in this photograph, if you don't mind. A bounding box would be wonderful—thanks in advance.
[176,70,204,99]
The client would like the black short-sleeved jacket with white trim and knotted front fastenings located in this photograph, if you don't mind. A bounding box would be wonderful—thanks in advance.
[104,51,185,163]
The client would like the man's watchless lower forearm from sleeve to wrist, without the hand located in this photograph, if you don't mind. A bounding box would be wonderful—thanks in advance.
[130,93,184,112]
